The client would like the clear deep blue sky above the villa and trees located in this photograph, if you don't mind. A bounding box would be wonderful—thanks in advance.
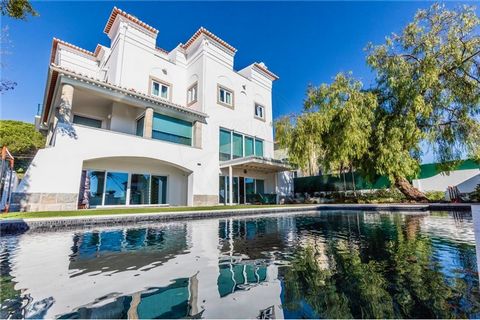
[0,1,476,162]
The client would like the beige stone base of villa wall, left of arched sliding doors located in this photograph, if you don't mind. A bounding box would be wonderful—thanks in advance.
[10,192,78,211]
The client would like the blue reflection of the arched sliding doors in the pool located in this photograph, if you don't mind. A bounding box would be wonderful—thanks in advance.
[69,224,188,275]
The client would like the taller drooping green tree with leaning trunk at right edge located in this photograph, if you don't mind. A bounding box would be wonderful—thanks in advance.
[367,4,480,200]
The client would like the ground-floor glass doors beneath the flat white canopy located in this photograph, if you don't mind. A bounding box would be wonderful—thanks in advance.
[218,176,265,204]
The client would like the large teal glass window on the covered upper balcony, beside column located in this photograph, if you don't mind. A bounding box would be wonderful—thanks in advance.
[152,113,193,146]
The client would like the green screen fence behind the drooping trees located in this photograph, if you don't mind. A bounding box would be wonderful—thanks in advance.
[293,159,480,194]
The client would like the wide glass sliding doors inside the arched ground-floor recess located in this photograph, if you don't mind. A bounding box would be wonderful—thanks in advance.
[79,170,167,207]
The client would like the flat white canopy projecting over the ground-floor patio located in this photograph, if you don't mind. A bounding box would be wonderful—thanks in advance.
[220,156,292,173]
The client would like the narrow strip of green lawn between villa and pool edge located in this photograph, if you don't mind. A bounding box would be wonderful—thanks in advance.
[0,205,292,219]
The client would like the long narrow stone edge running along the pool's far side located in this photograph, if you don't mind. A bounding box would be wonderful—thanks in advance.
[0,203,472,234]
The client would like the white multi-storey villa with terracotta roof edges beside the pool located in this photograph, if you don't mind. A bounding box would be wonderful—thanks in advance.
[12,8,289,211]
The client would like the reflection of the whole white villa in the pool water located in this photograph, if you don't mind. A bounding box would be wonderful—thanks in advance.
[12,219,283,318]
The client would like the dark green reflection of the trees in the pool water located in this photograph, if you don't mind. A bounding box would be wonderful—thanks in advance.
[281,215,480,318]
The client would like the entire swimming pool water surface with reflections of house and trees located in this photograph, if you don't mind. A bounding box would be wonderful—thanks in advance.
[0,211,480,318]
